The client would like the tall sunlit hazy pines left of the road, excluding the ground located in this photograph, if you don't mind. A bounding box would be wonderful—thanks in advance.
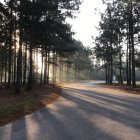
[0,0,92,93]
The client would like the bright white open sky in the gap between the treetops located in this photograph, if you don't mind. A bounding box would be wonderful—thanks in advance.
[67,0,105,46]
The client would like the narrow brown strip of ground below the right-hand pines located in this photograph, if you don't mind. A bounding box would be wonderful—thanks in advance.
[98,83,140,95]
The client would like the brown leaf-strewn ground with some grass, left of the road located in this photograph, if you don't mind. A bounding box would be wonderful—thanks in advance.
[0,85,60,126]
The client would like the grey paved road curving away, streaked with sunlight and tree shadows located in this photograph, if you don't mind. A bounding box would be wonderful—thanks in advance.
[0,83,140,140]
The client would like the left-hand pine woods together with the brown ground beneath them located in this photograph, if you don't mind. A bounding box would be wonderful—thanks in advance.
[0,0,93,126]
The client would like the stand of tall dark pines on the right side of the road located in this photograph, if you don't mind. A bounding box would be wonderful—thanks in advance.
[94,0,140,87]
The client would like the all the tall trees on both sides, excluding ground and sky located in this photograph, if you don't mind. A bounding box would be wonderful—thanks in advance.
[0,0,140,93]
